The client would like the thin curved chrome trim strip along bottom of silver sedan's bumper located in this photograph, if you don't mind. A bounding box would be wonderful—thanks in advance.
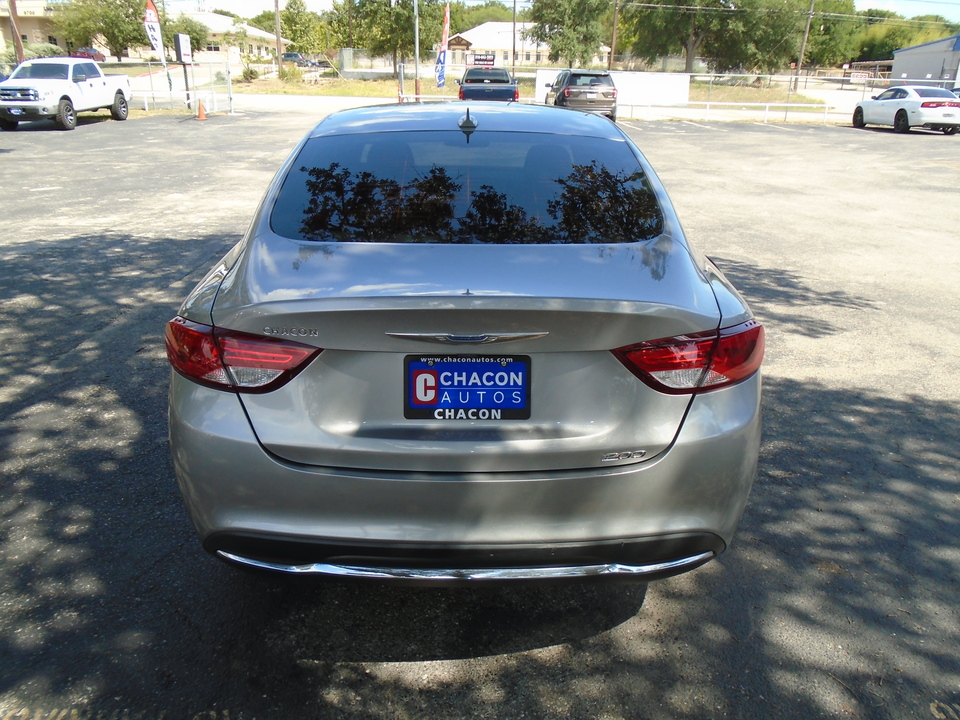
[217,550,714,582]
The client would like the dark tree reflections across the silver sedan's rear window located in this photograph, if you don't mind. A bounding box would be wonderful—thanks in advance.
[299,161,663,244]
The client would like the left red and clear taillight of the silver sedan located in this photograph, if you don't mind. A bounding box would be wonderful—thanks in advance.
[165,316,320,393]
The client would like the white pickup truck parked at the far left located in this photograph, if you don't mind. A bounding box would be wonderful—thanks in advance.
[0,58,130,130]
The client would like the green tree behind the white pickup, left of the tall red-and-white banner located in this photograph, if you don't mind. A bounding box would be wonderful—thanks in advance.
[54,0,149,60]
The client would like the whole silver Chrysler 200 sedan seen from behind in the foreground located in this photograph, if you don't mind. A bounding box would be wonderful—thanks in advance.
[166,102,764,582]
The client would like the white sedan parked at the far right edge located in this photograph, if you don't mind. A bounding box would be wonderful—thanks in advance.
[853,85,960,135]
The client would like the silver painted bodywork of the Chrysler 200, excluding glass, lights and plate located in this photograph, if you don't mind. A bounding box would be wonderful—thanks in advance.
[170,103,761,578]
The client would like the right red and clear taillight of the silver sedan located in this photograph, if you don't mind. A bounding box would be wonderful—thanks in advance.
[613,320,764,395]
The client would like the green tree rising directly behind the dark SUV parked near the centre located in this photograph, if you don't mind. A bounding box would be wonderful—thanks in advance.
[528,0,609,67]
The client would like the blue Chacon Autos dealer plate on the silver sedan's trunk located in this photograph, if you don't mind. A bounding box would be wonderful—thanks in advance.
[403,355,530,420]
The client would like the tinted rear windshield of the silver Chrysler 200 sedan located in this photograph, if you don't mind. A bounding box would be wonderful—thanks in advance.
[270,131,663,244]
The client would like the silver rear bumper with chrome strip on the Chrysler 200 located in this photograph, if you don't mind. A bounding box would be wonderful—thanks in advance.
[170,374,760,582]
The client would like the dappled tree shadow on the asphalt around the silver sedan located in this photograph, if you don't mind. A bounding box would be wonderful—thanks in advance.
[0,236,960,720]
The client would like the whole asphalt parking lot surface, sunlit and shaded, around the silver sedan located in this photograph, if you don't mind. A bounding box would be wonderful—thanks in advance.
[0,112,960,720]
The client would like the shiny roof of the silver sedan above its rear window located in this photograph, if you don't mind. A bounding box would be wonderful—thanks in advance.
[310,101,624,140]
